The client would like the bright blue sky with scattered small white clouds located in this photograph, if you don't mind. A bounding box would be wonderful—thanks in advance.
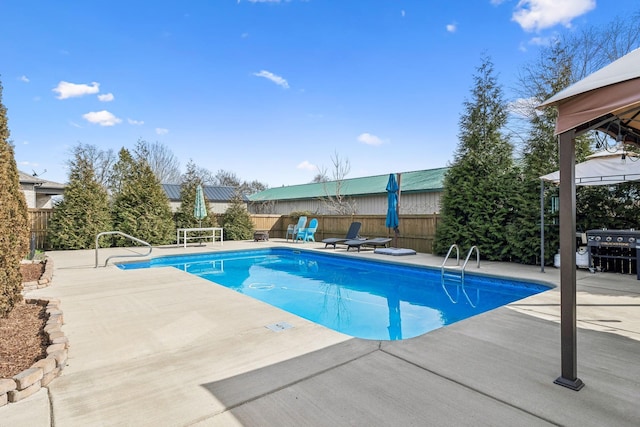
[0,0,638,187]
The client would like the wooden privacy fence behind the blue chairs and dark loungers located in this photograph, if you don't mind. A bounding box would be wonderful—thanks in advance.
[251,214,440,253]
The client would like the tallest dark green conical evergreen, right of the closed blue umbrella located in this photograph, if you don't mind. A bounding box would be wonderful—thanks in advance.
[434,54,518,260]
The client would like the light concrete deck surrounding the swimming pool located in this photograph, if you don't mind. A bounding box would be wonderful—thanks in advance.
[0,239,640,427]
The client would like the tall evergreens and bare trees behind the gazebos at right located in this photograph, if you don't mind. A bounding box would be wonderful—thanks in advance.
[434,13,640,264]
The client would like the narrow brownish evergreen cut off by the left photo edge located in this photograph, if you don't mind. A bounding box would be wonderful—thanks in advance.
[0,80,29,317]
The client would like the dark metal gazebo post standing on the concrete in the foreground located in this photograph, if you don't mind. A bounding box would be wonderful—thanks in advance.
[554,129,584,391]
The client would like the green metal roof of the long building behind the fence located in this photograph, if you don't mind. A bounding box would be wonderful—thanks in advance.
[249,168,449,202]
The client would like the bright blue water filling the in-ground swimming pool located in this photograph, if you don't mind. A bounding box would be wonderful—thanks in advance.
[118,249,549,340]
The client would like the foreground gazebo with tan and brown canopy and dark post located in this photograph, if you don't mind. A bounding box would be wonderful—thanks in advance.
[538,49,640,391]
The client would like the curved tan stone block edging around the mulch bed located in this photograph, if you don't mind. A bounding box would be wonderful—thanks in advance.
[0,260,69,406]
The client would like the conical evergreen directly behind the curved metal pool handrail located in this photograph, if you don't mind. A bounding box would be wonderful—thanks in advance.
[111,148,175,246]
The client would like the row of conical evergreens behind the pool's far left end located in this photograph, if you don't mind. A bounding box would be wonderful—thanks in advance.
[47,141,253,249]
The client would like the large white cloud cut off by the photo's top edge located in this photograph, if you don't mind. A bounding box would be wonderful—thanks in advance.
[511,0,596,31]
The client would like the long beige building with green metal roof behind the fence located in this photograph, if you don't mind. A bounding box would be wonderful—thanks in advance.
[249,168,448,215]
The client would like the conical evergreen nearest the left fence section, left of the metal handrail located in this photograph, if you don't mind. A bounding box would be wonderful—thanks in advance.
[48,150,112,249]
